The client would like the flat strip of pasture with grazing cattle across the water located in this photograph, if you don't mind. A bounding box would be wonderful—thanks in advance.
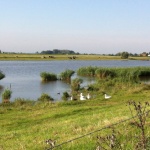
[0,53,149,60]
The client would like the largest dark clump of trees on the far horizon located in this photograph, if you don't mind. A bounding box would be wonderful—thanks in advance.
[41,49,77,54]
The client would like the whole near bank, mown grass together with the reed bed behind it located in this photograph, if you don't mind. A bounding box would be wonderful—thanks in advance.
[0,67,150,150]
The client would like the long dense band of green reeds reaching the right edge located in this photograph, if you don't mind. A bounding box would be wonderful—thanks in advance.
[77,67,150,82]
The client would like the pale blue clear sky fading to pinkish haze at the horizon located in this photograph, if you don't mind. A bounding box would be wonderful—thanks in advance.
[0,0,150,54]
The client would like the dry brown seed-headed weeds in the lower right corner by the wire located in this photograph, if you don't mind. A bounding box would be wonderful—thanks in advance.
[96,101,150,150]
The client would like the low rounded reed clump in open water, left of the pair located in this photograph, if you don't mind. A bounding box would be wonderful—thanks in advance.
[40,72,57,81]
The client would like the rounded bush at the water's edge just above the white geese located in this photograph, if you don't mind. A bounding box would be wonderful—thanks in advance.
[71,78,83,92]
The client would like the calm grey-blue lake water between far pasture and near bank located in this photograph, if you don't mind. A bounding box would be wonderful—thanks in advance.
[0,60,150,101]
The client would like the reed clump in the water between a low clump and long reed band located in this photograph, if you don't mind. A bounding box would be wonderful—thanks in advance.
[60,69,75,81]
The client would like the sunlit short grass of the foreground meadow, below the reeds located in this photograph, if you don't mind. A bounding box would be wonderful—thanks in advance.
[0,84,150,150]
